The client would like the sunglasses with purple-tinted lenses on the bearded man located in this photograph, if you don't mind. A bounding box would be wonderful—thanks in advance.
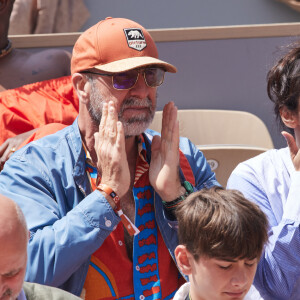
[82,67,165,90]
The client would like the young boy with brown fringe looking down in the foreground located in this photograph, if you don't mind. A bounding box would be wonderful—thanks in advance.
[174,187,268,300]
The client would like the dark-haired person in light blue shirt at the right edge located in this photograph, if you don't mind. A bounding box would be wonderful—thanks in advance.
[227,45,300,300]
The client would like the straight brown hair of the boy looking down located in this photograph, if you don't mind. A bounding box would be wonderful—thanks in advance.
[176,187,268,260]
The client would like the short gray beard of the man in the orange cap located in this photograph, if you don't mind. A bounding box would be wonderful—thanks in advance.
[88,85,155,137]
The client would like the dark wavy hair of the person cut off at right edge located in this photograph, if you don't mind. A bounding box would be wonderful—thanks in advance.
[267,42,300,133]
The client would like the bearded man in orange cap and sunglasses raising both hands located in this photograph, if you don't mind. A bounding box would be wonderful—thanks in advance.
[0,18,218,299]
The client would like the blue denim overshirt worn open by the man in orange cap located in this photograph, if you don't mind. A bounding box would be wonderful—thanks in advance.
[0,119,218,295]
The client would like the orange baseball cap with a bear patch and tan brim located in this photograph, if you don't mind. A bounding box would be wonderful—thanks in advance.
[71,17,177,74]
